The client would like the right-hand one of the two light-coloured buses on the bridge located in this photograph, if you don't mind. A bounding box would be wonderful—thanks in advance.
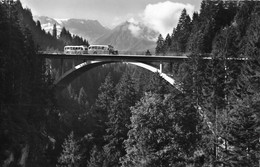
[88,45,118,54]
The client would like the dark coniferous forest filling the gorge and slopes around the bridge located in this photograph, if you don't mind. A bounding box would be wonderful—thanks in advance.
[0,0,260,167]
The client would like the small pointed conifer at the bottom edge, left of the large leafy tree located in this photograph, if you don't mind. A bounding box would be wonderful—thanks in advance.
[58,131,81,167]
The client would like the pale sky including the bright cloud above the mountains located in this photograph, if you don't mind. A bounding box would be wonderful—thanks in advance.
[20,0,202,35]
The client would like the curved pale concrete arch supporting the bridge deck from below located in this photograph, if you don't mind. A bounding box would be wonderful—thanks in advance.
[54,61,180,92]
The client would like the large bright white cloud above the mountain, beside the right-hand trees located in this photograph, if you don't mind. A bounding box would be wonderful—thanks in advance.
[142,1,195,36]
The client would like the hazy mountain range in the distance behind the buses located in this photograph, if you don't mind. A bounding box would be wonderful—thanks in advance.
[34,16,159,52]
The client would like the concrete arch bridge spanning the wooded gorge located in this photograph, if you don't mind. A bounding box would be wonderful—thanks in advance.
[38,53,188,91]
